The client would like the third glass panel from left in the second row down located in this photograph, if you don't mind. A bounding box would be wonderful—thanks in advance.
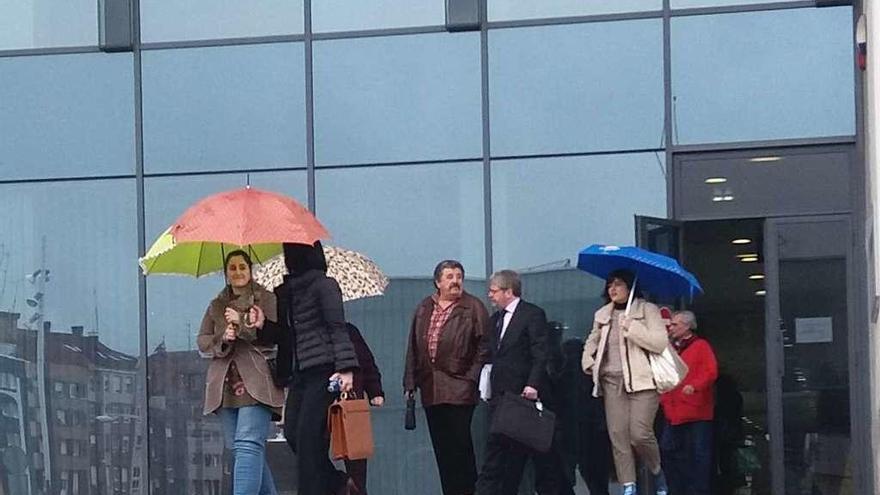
[314,33,482,165]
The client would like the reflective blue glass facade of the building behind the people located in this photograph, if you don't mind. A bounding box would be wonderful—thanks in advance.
[0,0,856,495]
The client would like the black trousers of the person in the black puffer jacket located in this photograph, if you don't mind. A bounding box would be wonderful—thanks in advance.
[284,367,347,495]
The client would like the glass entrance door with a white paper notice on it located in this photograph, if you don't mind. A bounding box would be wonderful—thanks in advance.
[764,215,853,495]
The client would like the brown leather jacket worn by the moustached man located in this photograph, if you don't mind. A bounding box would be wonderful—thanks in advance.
[403,292,489,406]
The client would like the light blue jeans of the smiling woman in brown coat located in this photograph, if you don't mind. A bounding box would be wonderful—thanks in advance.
[217,406,278,495]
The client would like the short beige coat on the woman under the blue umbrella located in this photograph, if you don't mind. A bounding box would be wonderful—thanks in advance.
[581,299,669,397]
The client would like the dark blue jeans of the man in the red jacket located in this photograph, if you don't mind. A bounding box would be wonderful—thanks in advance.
[660,421,713,495]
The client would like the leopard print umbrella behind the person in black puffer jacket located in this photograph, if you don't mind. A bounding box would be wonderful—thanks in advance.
[254,245,388,301]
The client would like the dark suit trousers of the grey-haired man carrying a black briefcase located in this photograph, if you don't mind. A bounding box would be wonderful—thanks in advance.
[477,401,539,495]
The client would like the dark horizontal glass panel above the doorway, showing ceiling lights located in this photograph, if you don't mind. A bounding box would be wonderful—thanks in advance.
[675,147,851,218]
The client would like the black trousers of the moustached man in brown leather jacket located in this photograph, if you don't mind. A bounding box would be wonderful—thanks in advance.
[425,404,477,495]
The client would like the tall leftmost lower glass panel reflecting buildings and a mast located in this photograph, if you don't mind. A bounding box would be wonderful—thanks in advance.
[0,179,147,494]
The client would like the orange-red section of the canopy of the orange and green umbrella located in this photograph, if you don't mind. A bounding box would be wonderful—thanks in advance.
[170,186,330,246]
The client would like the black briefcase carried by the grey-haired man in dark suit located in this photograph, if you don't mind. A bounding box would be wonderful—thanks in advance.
[489,394,556,453]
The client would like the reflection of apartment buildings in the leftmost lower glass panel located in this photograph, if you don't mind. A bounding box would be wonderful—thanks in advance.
[0,312,139,495]
